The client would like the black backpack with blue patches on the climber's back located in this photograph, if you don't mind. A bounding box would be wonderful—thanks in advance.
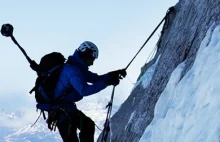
[30,52,65,114]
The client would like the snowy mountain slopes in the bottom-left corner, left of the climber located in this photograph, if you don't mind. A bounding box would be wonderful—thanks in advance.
[0,107,61,142]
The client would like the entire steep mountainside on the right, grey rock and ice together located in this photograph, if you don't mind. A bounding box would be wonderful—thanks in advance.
[98,0,220,142]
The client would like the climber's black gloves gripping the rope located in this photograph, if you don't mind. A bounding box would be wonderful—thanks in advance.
[108,69,127,86]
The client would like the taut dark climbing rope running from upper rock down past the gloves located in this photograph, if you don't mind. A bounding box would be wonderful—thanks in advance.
[101,7,174,142]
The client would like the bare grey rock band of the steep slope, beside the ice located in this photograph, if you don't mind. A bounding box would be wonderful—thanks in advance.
[98,0,220,142]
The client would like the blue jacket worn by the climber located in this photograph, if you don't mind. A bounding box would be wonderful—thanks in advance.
[55,51,109,103]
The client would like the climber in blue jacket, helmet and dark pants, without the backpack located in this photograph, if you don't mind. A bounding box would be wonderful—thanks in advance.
[47,41,126,142]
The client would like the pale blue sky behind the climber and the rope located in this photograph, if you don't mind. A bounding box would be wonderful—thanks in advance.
[0,0,177,140]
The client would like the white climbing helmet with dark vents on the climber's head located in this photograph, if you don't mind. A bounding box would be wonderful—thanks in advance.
[78,41,99,59]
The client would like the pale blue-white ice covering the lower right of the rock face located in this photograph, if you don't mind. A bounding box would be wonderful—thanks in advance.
[138,25,220,142]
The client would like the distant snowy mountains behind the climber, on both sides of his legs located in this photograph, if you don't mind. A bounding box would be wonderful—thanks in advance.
[0,96,118,142]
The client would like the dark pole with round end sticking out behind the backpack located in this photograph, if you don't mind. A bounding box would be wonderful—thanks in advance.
[1,24,38,72]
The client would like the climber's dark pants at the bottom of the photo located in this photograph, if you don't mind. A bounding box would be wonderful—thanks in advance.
[57,110,95,142]
